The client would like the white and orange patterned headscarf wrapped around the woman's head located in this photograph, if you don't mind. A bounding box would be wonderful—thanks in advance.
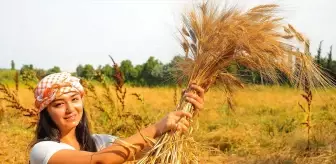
[34,72,84,112]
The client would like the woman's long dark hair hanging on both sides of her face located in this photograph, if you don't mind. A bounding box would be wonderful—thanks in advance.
[30,109,97,152]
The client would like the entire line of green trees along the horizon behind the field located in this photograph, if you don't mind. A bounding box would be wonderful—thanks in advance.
[7,41,336,86]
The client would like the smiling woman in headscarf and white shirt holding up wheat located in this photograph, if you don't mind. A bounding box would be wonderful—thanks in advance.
[30,73,204,164]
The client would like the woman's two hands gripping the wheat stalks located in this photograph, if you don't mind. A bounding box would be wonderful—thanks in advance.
[154,85,204,137]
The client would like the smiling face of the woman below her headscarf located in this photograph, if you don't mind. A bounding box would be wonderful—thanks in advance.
[47,92,83,132]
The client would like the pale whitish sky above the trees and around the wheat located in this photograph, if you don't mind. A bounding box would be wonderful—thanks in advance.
[0,0,336,71]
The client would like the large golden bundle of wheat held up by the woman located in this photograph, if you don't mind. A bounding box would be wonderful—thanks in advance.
[138,3,330,164]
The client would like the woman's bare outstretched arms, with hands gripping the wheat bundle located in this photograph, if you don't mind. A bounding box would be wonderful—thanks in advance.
[48,86,204,164]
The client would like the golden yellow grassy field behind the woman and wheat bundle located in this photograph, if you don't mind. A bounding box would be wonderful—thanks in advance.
[0,86,336,164]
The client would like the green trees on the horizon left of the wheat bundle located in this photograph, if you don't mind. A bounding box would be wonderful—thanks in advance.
[11,56,183,86]
